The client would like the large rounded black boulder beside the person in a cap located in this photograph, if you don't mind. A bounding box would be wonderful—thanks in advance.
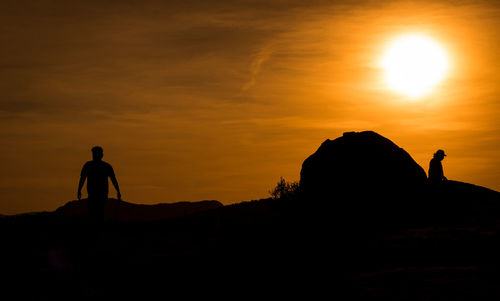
[300,131,427,198]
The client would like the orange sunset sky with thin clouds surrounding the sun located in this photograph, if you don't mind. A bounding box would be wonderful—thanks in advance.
[0,0,500,214]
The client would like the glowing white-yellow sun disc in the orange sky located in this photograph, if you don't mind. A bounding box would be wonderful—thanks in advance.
[381,35,449,98]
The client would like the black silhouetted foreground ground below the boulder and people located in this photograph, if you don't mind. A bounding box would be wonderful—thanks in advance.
[0,182,500,300]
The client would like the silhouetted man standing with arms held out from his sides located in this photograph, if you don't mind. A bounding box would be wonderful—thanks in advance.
[78,146,121,223]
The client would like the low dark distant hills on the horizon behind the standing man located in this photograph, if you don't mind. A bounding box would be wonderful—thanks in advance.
[54,199,223,222]
